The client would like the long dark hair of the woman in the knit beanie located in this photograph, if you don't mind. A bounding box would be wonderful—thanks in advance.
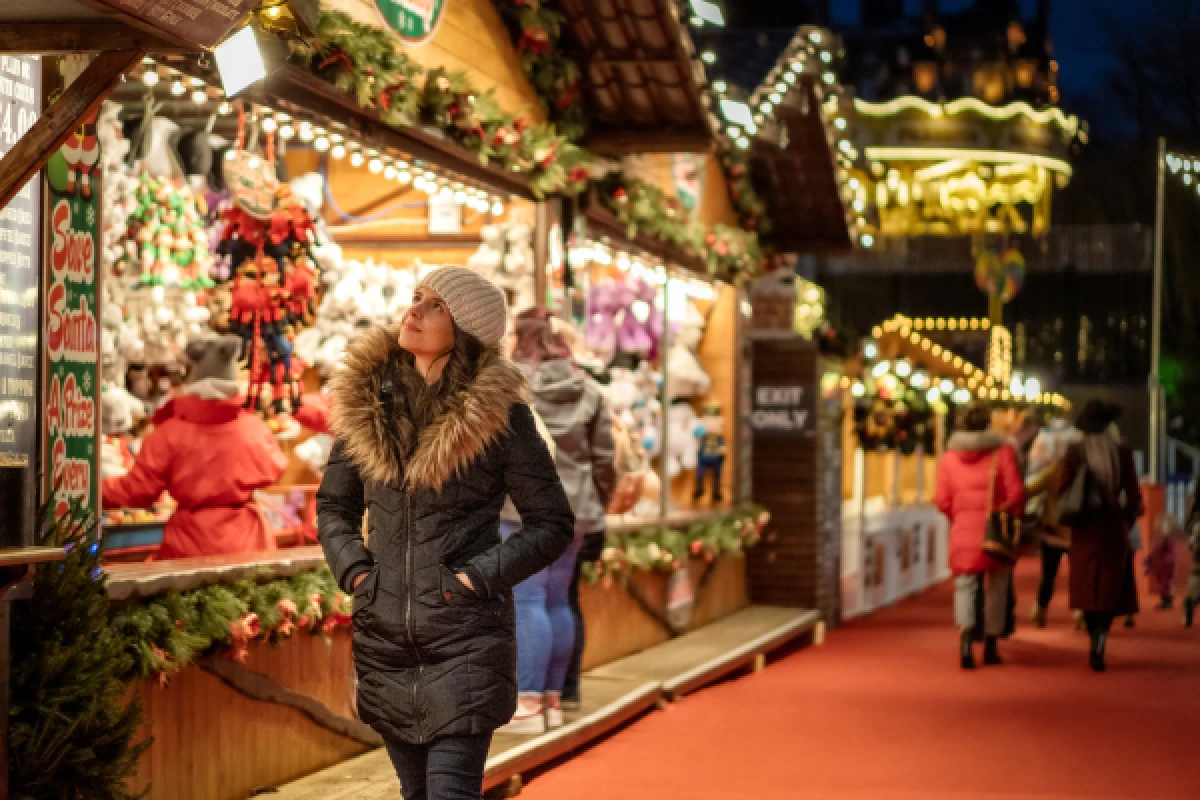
[392,325,489,458]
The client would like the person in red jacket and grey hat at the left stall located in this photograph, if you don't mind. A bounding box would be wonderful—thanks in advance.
[102,335,288,560]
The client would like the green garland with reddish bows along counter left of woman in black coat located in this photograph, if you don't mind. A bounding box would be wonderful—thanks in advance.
[113,567,350,685]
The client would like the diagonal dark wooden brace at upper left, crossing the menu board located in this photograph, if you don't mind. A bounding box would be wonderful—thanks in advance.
[0,50,144,209]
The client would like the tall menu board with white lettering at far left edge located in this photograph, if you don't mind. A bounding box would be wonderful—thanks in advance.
[0,55,42,547]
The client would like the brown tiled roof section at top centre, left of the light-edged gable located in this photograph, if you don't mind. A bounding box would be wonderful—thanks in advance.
[559,0,714,156]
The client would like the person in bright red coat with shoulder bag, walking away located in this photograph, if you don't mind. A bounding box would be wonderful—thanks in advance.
[935,403,1025,669]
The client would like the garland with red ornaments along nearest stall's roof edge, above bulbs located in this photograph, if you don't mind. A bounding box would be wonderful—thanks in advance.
[292,11,589,198]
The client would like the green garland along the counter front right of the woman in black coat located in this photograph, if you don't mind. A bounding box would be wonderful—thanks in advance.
[581,505,770,589]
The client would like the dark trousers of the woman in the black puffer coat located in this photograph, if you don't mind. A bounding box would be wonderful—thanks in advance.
[385,732,492,800]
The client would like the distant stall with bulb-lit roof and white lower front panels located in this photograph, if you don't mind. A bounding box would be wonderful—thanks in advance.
[826,314,1066,616]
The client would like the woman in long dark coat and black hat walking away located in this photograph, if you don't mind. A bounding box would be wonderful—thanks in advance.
[1061,401,1142,672]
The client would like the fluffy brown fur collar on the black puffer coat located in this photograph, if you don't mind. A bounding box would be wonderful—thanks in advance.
[330,327,527,492]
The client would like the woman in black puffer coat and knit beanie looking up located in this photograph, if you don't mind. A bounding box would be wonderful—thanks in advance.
[317,267,575,800]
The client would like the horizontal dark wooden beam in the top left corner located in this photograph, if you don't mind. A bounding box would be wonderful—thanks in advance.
[0,19,184,55]
